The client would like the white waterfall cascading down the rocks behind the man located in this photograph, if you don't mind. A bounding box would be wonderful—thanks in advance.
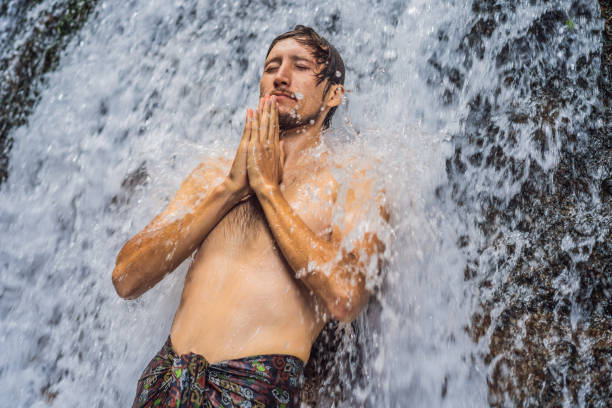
[0,0,612,407]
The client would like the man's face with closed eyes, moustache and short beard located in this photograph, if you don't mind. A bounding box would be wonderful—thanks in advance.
[259,38,328,129]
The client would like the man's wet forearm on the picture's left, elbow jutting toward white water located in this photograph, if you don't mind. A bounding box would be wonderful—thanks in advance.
[113,183,239,299]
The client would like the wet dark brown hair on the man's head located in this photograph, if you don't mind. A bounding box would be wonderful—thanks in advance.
[266,24,345,129]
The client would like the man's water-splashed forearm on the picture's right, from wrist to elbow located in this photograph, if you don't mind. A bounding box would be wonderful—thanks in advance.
[257,187,365,320]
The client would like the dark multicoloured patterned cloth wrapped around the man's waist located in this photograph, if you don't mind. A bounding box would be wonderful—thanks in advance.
[133,337,304,408]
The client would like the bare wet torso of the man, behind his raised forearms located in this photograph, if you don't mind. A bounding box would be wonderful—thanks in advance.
[171,156,336,363]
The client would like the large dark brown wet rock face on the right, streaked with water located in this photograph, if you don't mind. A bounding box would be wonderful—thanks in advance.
[441,1,612,407]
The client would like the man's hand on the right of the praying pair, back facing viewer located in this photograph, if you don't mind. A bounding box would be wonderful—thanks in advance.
[247,97,284,193]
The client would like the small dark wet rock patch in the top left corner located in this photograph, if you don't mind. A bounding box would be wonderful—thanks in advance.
[0,0,97,184]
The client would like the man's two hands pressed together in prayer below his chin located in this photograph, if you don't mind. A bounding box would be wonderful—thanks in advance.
[228,96,284,201]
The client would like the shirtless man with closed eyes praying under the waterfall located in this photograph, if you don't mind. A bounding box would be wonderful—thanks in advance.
[113,26,383,407]
